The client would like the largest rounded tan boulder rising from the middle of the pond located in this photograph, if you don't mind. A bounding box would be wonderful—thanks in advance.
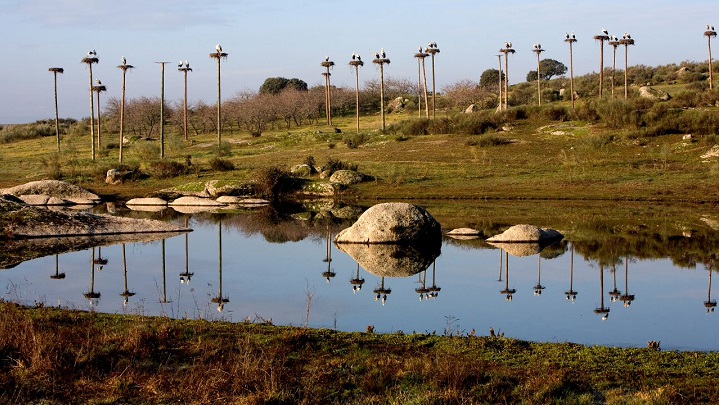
[335,203,442,245]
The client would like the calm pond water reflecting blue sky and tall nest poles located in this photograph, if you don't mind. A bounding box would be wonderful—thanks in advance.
[0,202,718,351]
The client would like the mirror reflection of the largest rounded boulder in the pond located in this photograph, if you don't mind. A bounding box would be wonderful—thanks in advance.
[335,243,440,277]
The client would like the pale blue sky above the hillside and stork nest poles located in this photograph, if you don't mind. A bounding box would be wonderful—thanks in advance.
[0,0,720,123]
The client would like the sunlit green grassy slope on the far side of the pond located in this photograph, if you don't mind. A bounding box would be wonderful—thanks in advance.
[0,100,718,203]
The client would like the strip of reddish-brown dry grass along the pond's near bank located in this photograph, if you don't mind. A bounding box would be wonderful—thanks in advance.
[0,303,718,404]
